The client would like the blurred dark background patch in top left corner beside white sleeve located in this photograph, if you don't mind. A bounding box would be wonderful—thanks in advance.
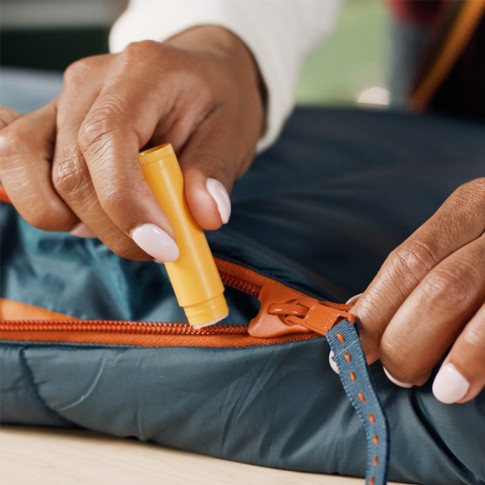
[0,0,127,71]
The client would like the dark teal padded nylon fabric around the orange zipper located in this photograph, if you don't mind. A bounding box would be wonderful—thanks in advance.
[0,70,485,485]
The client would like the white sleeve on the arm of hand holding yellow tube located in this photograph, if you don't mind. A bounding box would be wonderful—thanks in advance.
[110,0,342,150]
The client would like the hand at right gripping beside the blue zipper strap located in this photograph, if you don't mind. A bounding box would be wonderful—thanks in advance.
[351,178,485,403]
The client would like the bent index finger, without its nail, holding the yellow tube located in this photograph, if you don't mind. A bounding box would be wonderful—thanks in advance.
[79,70,178,240]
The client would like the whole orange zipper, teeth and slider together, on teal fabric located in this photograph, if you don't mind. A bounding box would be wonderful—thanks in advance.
[0,258,354,347]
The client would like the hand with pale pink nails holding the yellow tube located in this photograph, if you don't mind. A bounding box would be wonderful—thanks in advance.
[0,26,264,261]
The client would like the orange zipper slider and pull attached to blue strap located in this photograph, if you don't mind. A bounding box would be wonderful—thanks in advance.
[248,283,356,338]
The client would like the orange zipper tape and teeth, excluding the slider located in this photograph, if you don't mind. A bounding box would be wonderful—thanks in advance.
[0,233,326,348]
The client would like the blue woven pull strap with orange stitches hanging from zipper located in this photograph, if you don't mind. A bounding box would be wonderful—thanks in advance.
[327,320,389,485]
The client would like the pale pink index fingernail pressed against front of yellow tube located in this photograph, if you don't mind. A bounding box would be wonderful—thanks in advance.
[131,224,179,263]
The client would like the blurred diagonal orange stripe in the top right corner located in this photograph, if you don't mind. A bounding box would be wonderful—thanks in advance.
[410,0,485,111]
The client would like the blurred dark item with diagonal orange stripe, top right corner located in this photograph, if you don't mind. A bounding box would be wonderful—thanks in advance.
[388,0,485,121]
